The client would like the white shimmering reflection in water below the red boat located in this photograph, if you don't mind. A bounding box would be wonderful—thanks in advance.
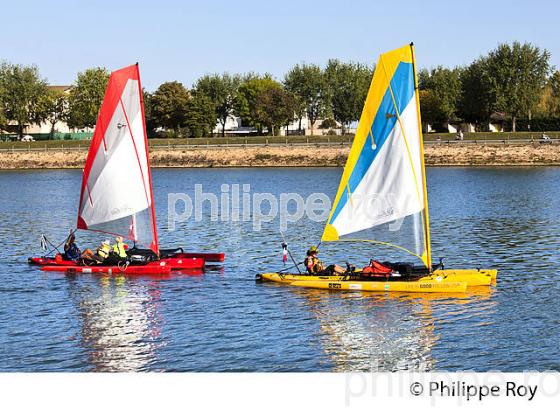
[67,276,162,372]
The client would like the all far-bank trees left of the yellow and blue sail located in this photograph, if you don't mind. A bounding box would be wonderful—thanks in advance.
[0,59,373,137]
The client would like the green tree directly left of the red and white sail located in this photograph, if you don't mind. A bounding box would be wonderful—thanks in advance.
[68,67,109,128]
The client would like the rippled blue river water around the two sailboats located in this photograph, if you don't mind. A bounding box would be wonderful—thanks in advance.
[0,168,560,372]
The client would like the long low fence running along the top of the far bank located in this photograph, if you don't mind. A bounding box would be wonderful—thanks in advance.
[0,137,560,152]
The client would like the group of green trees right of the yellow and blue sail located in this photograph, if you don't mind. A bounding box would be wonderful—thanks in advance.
[418,42,560,132]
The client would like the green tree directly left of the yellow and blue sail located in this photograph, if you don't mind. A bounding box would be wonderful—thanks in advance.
[325,60,373,134]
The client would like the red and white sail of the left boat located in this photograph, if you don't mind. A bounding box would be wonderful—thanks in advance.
[78,64,159,253]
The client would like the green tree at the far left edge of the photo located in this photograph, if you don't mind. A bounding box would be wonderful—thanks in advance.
[0,63,47,138]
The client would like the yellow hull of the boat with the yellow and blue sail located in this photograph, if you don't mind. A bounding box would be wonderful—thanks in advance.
[260,269,498,292]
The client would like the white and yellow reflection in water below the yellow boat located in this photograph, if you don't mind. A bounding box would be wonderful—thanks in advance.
[298,289,491,372]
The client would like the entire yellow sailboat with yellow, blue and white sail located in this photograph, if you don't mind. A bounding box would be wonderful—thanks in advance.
[257,44,497,293]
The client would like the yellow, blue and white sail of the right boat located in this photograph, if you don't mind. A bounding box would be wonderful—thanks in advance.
[322,45,430,266]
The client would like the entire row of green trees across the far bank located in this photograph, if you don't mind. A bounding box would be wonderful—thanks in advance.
[0,42,560,137]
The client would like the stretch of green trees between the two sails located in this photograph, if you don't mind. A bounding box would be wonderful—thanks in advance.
[144,59,373,137]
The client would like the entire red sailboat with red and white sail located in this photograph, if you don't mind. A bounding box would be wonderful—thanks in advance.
[29,64,224,274]
